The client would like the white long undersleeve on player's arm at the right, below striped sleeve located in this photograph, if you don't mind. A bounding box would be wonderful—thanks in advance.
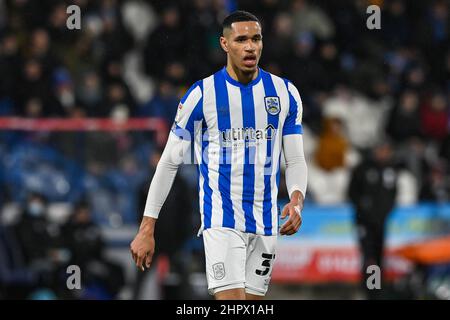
[283,134,308,199]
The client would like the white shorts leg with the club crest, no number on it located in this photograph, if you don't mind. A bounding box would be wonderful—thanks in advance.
[203,228,246,295]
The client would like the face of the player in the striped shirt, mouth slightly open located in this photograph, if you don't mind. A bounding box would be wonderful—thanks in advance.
[221,21,263,73]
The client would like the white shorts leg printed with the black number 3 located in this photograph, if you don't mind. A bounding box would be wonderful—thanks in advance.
[245,235,277,298]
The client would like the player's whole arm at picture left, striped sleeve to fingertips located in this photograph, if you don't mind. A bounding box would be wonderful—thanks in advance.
[130,82,203,271]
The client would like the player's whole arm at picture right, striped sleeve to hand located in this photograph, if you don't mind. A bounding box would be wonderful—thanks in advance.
[280,82,308,235]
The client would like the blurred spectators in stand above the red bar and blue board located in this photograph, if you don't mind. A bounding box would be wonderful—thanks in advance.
[0,0,450,204]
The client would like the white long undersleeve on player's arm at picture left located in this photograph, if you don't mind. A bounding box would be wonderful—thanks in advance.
[144,132,191,219]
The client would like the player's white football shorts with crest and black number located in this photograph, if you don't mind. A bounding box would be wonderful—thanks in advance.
[203,228,277,296]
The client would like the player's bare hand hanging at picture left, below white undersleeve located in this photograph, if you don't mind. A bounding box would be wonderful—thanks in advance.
[130,218,155,271]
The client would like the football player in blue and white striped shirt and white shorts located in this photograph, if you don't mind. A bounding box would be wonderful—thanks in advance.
[131,11,307,300]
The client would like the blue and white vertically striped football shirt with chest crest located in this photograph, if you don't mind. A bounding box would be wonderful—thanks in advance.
[172,68,302,235]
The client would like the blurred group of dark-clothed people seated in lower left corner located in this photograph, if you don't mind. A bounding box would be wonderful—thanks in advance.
[0,193,125,299]
